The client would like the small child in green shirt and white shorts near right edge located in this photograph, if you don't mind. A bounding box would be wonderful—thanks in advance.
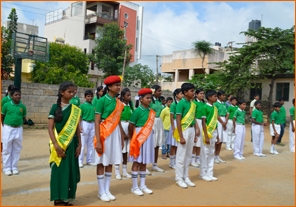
[269,102,282,155]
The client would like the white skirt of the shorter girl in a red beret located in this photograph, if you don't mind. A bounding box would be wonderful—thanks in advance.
[128,127,155,164]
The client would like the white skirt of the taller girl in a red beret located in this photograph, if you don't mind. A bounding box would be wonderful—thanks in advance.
[92,125,122,166]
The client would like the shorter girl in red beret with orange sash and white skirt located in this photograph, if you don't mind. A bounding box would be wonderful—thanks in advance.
[128,88,156,196]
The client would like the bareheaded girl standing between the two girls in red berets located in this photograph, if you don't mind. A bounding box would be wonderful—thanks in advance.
[115,88,134,180]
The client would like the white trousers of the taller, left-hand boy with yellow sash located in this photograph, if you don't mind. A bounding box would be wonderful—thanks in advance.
[175,127,195,181]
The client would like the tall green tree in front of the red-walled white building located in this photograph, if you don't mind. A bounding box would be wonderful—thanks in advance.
[90,23,133,77]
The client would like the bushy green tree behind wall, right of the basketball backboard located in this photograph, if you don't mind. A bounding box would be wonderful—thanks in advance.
[31,43,94,88]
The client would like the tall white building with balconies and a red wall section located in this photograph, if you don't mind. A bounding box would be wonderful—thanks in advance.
[44,1,143,86]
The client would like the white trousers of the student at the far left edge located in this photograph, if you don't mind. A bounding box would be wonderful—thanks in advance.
[1,125,23,172]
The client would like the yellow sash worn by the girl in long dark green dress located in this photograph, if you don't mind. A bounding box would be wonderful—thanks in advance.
[49,104,81,167]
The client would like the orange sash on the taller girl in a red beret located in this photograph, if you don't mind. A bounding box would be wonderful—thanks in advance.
[94,99,124,157]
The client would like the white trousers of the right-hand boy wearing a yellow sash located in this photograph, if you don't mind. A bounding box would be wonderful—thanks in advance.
[199,129,218,177]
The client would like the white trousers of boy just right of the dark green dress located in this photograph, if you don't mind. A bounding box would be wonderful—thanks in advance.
[79,120,96,164]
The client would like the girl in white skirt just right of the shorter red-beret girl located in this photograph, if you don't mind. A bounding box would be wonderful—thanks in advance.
[146,85,165,174]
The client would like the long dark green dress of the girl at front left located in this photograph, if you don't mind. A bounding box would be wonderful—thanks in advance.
[48,104,80,201]
